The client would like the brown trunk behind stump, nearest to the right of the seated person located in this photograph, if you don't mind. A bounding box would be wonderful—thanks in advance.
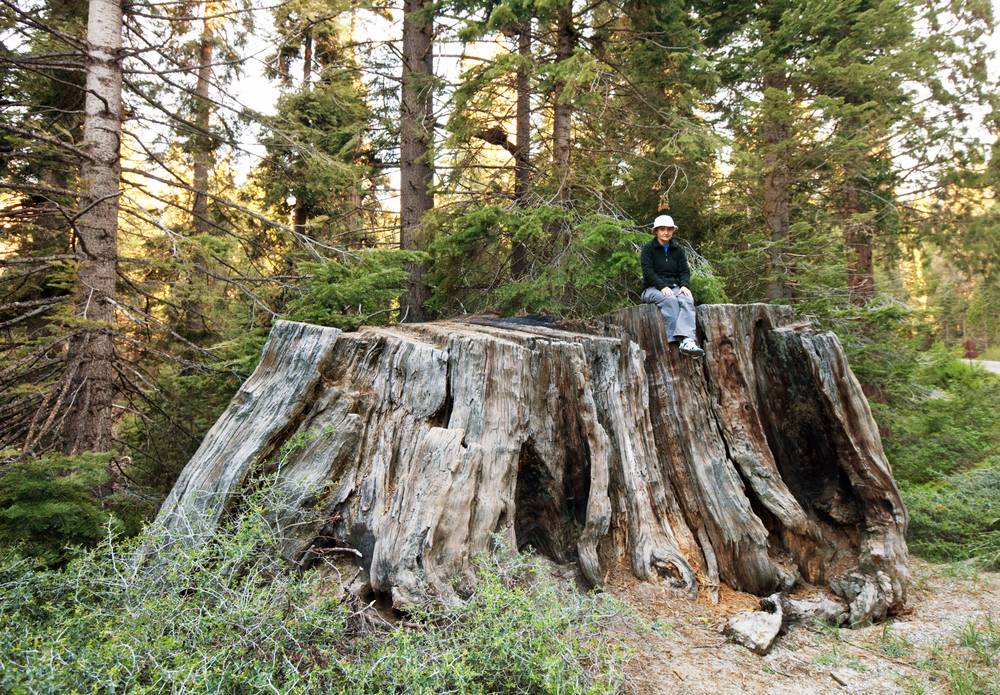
[762,71,792,299]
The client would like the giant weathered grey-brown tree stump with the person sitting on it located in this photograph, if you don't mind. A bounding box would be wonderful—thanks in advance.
[157,304,907,622]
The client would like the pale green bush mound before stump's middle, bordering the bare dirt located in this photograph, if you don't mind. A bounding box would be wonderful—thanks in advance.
[344,555,623,693]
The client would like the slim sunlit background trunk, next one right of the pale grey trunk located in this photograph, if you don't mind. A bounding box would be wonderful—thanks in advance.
[191,0,217,234]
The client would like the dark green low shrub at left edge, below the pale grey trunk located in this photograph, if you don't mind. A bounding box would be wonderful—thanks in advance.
[0,453,112,565]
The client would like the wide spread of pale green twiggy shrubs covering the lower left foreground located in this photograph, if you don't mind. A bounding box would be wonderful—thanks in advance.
[0,484,621,693]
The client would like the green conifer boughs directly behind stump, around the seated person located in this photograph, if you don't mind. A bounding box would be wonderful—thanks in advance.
[428,205,726,318]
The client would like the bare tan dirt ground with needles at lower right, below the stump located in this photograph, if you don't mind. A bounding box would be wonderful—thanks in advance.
[596,559,1000,695]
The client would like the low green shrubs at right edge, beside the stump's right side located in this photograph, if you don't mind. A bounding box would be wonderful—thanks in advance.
[825,302,1000,568]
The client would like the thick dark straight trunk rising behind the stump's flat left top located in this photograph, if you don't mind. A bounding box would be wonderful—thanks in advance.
[399,0,434,321]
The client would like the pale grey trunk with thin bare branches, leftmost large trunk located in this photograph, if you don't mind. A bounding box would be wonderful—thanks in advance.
[53,0,122,454]
